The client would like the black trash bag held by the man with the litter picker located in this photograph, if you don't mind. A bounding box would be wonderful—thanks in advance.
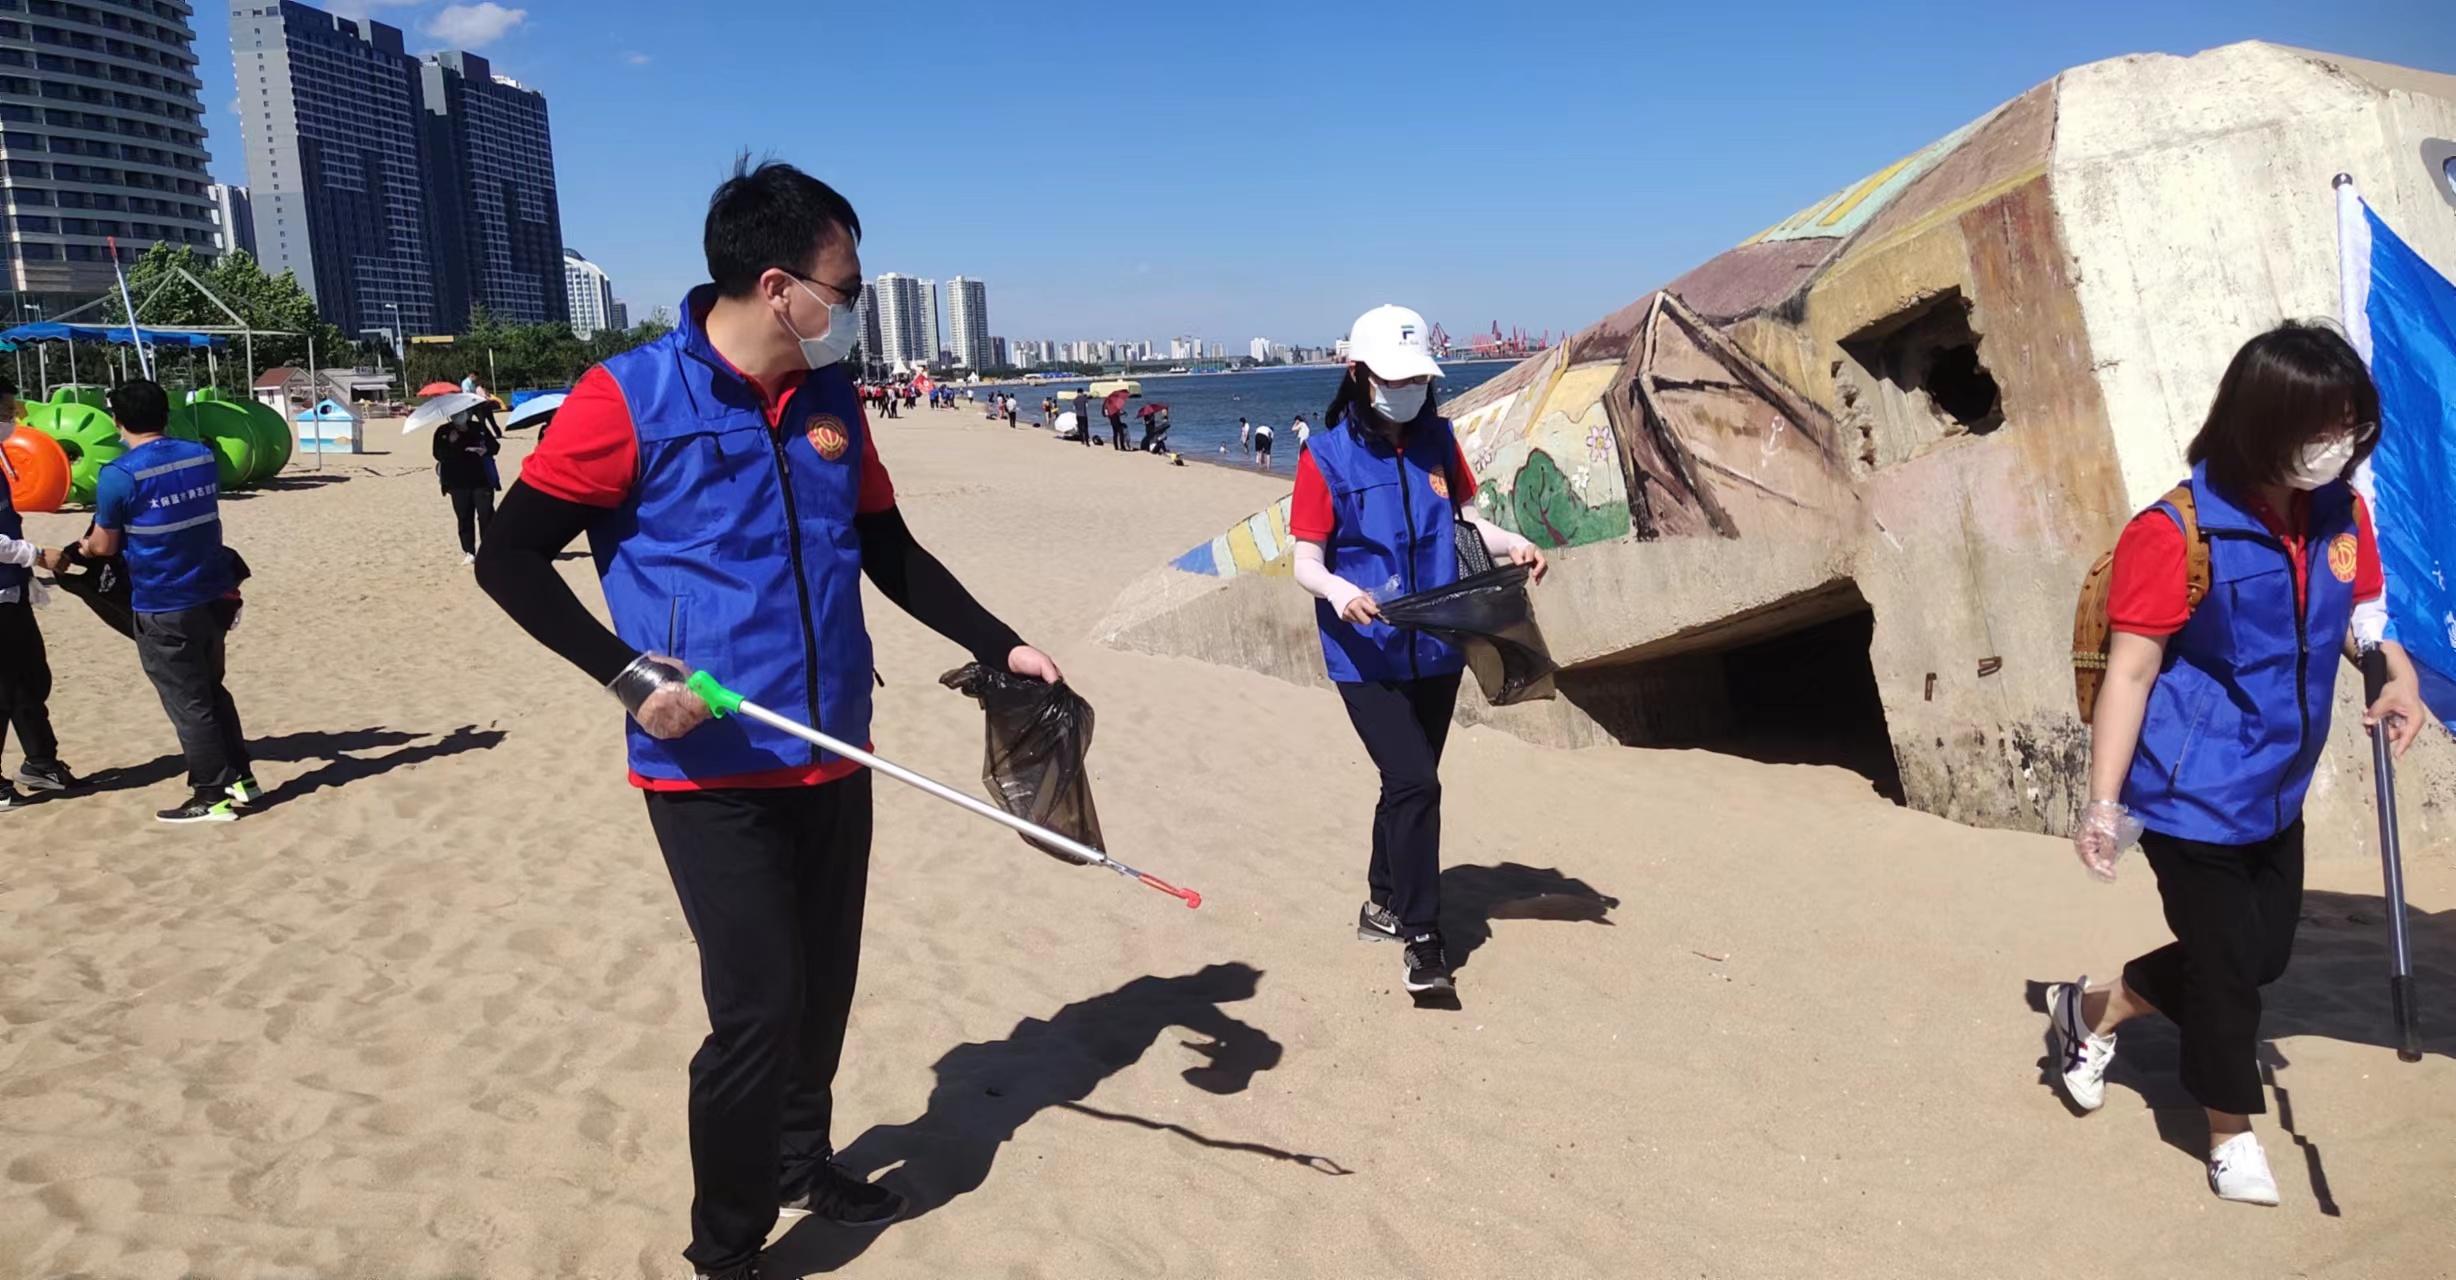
[938,663,1108,865]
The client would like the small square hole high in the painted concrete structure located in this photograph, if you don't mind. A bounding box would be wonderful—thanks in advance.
[1840,290,2004,464]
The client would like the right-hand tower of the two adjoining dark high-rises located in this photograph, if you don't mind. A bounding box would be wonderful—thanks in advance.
[418,52,572,329]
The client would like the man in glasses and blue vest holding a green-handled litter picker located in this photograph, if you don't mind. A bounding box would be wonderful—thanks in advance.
[476,162,1059,1278]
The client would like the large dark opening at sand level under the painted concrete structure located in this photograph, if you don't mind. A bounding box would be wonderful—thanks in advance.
[1560,582,1901,803]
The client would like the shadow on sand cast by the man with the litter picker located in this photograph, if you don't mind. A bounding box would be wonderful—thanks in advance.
[761,963,1348,1275]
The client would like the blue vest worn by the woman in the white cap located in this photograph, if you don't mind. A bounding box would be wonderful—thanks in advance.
[1309,413,1466,683]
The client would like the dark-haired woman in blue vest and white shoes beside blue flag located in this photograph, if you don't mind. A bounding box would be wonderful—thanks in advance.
[2046,324,2424,1204]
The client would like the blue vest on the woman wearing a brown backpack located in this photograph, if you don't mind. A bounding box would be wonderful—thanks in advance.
[2124,467,2358,845]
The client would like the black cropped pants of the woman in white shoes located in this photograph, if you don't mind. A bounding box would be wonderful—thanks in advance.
[2124,818,2304,1115]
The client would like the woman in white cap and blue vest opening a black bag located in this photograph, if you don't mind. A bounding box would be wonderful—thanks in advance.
[1287,307,1545,995]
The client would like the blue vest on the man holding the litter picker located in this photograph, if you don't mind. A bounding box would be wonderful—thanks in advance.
[589,285,872,779]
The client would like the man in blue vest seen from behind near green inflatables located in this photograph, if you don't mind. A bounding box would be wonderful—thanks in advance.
[57,378,260,823]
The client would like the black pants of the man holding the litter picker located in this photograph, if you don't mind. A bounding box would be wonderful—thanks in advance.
[648,771,869,1273]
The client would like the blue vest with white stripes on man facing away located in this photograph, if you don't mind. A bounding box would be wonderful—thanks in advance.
[103,437,233,614]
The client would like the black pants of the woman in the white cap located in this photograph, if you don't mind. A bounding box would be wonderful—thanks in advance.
[1339,673,1459,934]
